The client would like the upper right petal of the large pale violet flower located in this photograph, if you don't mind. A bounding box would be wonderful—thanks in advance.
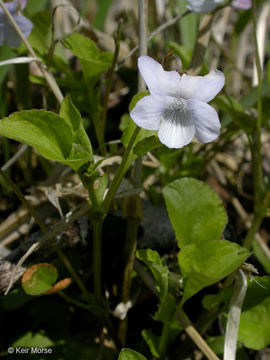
[180,70,225,102]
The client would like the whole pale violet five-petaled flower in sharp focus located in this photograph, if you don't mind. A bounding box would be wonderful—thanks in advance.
[130,56,225,148]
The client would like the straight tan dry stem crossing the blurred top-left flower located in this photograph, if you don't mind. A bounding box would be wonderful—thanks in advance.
[0,0,64,103]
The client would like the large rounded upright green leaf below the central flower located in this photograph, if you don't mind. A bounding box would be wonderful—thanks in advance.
[163,178,227,248]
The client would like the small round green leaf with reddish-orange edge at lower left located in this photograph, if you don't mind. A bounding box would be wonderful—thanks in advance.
[22,263,58,295]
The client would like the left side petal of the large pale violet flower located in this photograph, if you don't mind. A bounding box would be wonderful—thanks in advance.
[130,95,167,130]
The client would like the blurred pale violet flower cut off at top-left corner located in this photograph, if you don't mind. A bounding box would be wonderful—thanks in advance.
[0,0,33,47]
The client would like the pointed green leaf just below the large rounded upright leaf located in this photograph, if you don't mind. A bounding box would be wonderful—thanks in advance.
[178,240,250,304]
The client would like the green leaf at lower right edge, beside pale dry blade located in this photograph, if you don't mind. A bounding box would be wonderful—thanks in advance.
[238,276,270,350]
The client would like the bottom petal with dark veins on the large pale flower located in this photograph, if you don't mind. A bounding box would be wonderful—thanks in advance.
[158,100,195,149]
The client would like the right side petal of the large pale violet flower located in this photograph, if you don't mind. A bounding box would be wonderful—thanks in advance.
[187,99,220,143]
